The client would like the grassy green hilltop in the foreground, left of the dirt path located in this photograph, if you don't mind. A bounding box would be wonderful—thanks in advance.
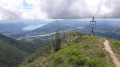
[19,32,119,67]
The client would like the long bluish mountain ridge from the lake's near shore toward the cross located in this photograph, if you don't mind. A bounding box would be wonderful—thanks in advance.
[10,20,89,38]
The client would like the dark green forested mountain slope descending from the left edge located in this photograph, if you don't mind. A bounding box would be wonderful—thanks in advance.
[0,34,44,67]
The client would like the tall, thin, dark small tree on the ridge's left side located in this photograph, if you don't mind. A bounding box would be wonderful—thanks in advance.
[53,26,62,51]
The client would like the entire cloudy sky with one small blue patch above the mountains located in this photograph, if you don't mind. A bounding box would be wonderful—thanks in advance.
[0,0,120,20]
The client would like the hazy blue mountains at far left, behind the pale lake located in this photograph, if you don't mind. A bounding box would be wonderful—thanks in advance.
[0,20,49,35]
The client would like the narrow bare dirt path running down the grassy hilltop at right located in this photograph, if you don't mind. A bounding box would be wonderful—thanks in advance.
[104,40,120,67]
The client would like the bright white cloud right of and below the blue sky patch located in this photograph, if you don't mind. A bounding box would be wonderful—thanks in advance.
[23,0,47,19]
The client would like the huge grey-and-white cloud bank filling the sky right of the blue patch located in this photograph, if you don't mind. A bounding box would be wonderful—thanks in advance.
[25,0,120,19]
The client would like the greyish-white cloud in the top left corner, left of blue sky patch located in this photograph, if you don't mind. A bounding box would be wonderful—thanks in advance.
[0,0,23,20]
